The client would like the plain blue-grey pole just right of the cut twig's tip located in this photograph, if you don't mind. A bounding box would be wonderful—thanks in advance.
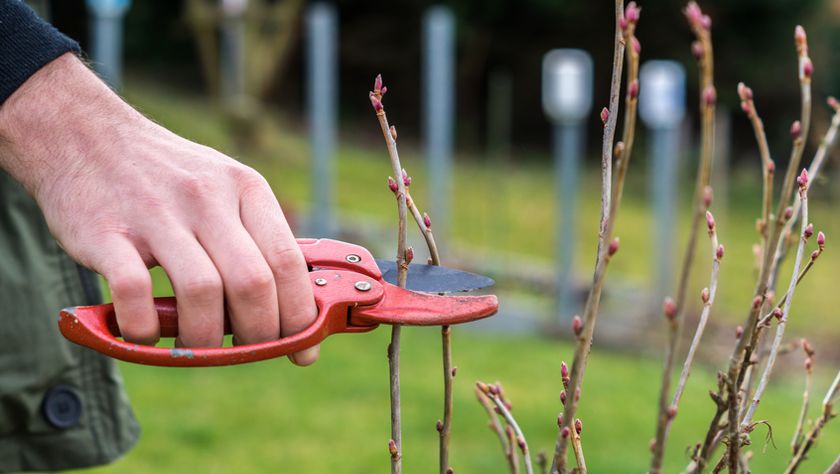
[423,6,455,243]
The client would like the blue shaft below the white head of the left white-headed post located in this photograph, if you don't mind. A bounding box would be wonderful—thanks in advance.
[553,122,585,324]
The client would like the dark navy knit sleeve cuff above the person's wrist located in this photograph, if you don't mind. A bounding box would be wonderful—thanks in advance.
[0,0,79,104]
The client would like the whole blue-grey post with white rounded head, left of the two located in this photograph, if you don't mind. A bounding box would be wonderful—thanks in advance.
[542,49,592,325]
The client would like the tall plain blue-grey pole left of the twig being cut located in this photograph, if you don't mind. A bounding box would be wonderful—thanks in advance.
[306,3,338,237]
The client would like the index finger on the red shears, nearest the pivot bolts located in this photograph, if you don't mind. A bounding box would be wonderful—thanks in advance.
[240,181,319,365]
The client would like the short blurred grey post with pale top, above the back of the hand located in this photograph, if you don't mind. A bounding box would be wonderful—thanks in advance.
[219,0,248,105]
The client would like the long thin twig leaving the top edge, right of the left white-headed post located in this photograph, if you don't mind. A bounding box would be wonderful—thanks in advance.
[551,0,625,474]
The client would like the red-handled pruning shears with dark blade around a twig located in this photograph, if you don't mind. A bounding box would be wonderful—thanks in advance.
[58,239,499,367]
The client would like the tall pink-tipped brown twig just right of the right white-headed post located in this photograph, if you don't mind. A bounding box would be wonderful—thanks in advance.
[650,2,717,474]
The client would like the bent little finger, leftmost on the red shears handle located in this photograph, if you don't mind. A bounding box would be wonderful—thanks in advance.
[93,238,160,345]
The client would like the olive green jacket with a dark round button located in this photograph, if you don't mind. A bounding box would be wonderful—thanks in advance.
[0,171,140,472]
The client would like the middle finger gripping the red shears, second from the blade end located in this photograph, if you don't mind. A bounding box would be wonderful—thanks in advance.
[198,222,280,344]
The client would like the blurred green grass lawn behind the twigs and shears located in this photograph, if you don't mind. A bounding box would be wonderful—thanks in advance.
[67,79,840,473]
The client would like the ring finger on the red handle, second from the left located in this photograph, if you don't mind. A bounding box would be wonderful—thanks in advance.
[150,232,224,347]
